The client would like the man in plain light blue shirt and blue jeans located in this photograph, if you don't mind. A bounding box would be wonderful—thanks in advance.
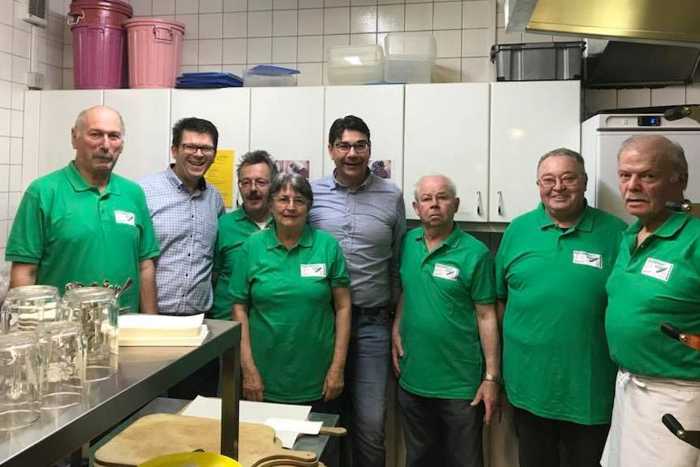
[309,115,406,467]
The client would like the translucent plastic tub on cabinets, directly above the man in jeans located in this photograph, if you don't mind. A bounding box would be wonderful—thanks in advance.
[384,32,437,83]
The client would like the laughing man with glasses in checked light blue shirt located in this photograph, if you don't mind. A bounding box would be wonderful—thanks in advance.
[139,117,224,315]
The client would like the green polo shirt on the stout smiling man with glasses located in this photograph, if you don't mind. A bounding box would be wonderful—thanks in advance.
[496,204,625,425]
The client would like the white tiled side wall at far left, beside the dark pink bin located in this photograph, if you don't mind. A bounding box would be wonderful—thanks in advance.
[0,0,65,252]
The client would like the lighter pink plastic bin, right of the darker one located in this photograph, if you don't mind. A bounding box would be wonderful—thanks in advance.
[124,18,185,88]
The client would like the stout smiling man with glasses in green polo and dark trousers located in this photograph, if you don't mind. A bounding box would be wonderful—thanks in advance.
[496,148,625,467]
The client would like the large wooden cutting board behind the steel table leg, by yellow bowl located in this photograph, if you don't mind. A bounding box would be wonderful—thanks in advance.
[95,414,318,467]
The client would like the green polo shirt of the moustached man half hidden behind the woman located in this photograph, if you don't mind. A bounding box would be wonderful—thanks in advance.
[208,208,270,320]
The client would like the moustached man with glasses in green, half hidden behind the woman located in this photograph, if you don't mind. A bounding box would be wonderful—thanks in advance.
[209,150,277,320]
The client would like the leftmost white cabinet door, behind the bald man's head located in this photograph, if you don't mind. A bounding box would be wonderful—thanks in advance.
[32,90,102,182]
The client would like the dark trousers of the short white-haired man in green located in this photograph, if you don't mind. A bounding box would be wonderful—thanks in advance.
[399,387,484,467]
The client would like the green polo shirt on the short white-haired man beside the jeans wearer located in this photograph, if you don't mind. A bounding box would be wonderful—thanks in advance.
[399,227,496,400]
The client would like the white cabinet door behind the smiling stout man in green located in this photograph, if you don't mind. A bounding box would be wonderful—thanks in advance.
[489,81,581,222]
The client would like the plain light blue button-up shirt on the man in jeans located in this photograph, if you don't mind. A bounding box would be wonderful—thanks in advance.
[309,174,406,307]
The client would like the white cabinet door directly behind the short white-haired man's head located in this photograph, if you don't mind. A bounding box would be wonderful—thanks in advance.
[404,83,489,222]
